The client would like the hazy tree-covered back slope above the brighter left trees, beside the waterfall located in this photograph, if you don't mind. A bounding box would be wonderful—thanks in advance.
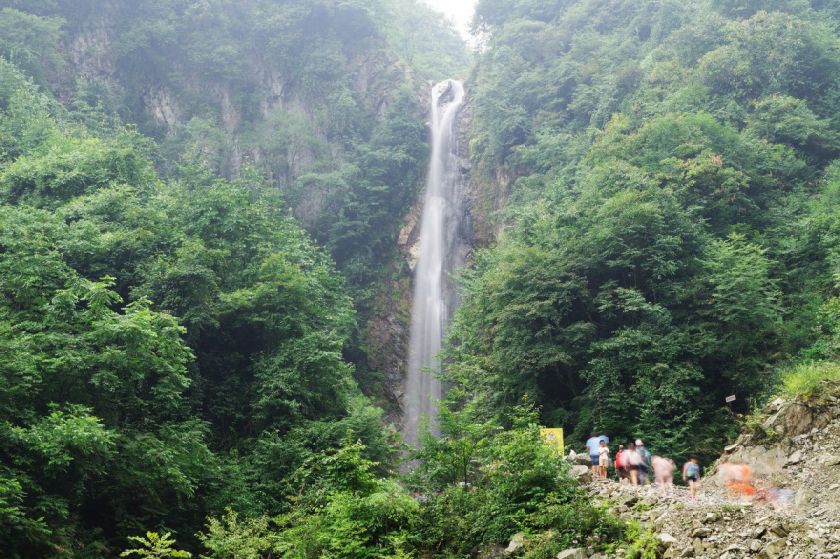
[0,0,469,392]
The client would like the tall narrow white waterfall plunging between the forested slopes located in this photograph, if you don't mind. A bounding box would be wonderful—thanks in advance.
[402,80,464,446]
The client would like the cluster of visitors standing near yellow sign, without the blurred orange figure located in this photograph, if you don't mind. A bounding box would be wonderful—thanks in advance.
[570,433,700,499]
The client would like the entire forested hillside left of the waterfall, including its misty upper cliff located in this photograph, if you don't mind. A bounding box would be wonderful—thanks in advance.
[0,1,467,557]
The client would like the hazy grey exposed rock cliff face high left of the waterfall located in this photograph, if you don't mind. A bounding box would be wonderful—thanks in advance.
[53,12,406,188]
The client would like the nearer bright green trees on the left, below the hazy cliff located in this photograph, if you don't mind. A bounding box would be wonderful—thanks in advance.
[0,55,390,557]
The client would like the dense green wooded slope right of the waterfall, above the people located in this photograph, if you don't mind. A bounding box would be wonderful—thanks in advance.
[451,0,840,457]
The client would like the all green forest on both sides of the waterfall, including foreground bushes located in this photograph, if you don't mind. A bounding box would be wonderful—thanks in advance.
[0,0,840,559]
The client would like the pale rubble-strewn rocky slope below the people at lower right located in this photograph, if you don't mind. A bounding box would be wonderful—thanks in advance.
[544,386,840,559]
